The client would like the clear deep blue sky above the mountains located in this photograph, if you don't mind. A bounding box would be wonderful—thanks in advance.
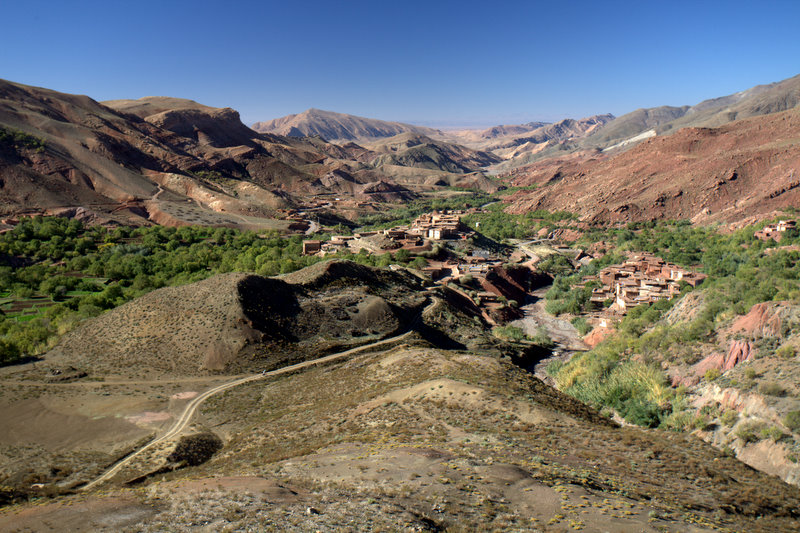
[0,0,800,126]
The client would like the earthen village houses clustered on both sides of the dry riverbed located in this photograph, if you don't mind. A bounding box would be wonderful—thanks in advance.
[303,210,712,323]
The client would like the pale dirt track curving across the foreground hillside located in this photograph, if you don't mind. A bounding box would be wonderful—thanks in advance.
[80,300,437,491]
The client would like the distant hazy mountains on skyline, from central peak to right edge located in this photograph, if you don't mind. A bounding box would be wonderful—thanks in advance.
[253,72,800,171]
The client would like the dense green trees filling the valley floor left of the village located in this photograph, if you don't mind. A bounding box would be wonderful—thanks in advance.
[0,217,425,363]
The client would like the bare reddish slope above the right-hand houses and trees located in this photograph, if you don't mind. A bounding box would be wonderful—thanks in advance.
[508,110,800,223]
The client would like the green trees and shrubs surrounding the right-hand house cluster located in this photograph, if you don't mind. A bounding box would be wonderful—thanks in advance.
[547,218,800,429]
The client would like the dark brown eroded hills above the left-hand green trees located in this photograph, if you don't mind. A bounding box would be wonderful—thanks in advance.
[0,81,434,229]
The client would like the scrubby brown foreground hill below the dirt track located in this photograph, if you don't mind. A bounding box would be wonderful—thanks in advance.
[7,341,800,533]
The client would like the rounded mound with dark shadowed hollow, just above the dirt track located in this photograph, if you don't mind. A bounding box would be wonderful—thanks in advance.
[48,261,494,375]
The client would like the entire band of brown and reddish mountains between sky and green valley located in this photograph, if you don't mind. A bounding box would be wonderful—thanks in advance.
[0,71,800,230]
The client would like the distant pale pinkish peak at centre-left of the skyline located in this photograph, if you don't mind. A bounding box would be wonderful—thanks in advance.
[253,108,440,142]
